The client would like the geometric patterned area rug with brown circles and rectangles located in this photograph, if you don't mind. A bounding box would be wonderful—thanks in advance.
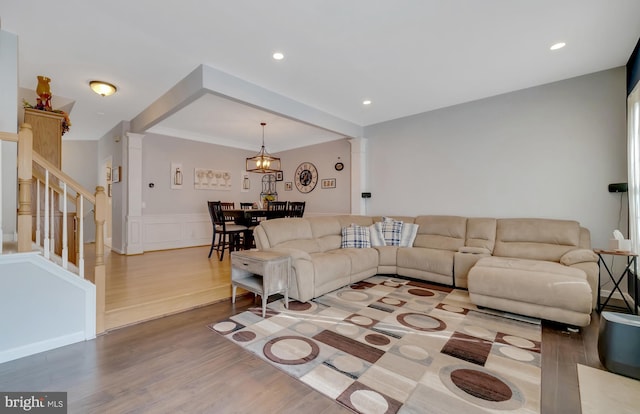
[209,275,541,414]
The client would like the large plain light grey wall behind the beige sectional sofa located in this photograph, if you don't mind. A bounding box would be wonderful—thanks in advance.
[365,68,627,247]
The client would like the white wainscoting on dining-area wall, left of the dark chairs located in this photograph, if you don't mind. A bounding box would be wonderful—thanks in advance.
[143,214,212,251]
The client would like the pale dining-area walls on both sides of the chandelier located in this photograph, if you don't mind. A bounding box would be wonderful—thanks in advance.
[134,134,350,251]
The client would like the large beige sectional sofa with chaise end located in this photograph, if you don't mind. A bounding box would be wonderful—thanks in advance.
[254,215,598,326]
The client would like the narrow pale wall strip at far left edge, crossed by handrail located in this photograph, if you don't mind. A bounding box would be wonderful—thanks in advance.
[0,30,18,242]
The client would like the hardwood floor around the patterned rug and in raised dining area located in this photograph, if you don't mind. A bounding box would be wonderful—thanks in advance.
[0,247,602,414]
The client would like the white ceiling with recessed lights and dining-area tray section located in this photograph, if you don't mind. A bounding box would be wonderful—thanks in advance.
[0,0,640,152]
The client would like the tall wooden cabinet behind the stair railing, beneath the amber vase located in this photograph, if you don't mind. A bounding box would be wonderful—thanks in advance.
[24,108,77,263]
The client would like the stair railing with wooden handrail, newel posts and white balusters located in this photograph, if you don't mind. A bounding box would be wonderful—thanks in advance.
[0,124,107,334]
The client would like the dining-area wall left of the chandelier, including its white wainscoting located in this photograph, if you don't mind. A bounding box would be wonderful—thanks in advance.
[140,134,262,251]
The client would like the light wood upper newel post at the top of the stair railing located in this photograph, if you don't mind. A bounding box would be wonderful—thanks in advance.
[17,124,33,252]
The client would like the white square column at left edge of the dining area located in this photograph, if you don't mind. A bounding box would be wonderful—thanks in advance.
[121,132,144,255]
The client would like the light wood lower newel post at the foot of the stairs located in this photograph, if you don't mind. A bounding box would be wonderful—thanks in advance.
[94,186,107,334]
